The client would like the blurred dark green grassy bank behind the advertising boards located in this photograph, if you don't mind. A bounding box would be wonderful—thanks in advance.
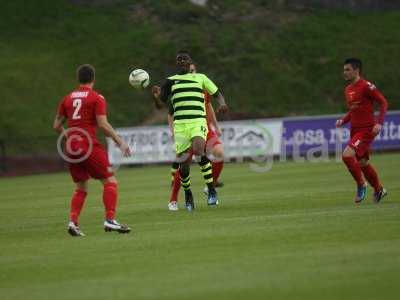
[0,0,400,140]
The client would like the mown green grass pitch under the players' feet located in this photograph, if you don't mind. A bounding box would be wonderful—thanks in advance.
[0,153,400,300]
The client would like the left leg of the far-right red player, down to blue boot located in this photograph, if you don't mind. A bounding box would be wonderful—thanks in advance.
[342,135,367,203]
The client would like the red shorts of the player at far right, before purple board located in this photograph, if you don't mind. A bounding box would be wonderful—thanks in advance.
[348,127,376,160]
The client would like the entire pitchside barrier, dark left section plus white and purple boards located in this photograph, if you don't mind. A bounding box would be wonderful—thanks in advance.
[0,111,400,176]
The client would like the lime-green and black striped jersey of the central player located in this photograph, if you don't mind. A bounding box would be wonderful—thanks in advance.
[161,73,218,123]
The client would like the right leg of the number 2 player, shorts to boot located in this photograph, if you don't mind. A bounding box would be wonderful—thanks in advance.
[85,144,130,233]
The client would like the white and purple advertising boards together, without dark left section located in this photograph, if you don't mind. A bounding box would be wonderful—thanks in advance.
[108,111,400,164]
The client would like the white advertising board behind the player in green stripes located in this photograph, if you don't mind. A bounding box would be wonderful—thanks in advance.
[107,119,282,165]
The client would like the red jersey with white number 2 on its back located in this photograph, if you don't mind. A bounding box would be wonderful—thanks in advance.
[58,86,107,141]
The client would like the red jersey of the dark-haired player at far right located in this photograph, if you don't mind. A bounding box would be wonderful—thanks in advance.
[342,78,387,128]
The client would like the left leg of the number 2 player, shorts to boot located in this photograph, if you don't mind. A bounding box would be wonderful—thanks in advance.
[67,163,89,236]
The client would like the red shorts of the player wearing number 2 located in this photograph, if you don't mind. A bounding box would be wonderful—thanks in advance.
[69,143,114,182]
